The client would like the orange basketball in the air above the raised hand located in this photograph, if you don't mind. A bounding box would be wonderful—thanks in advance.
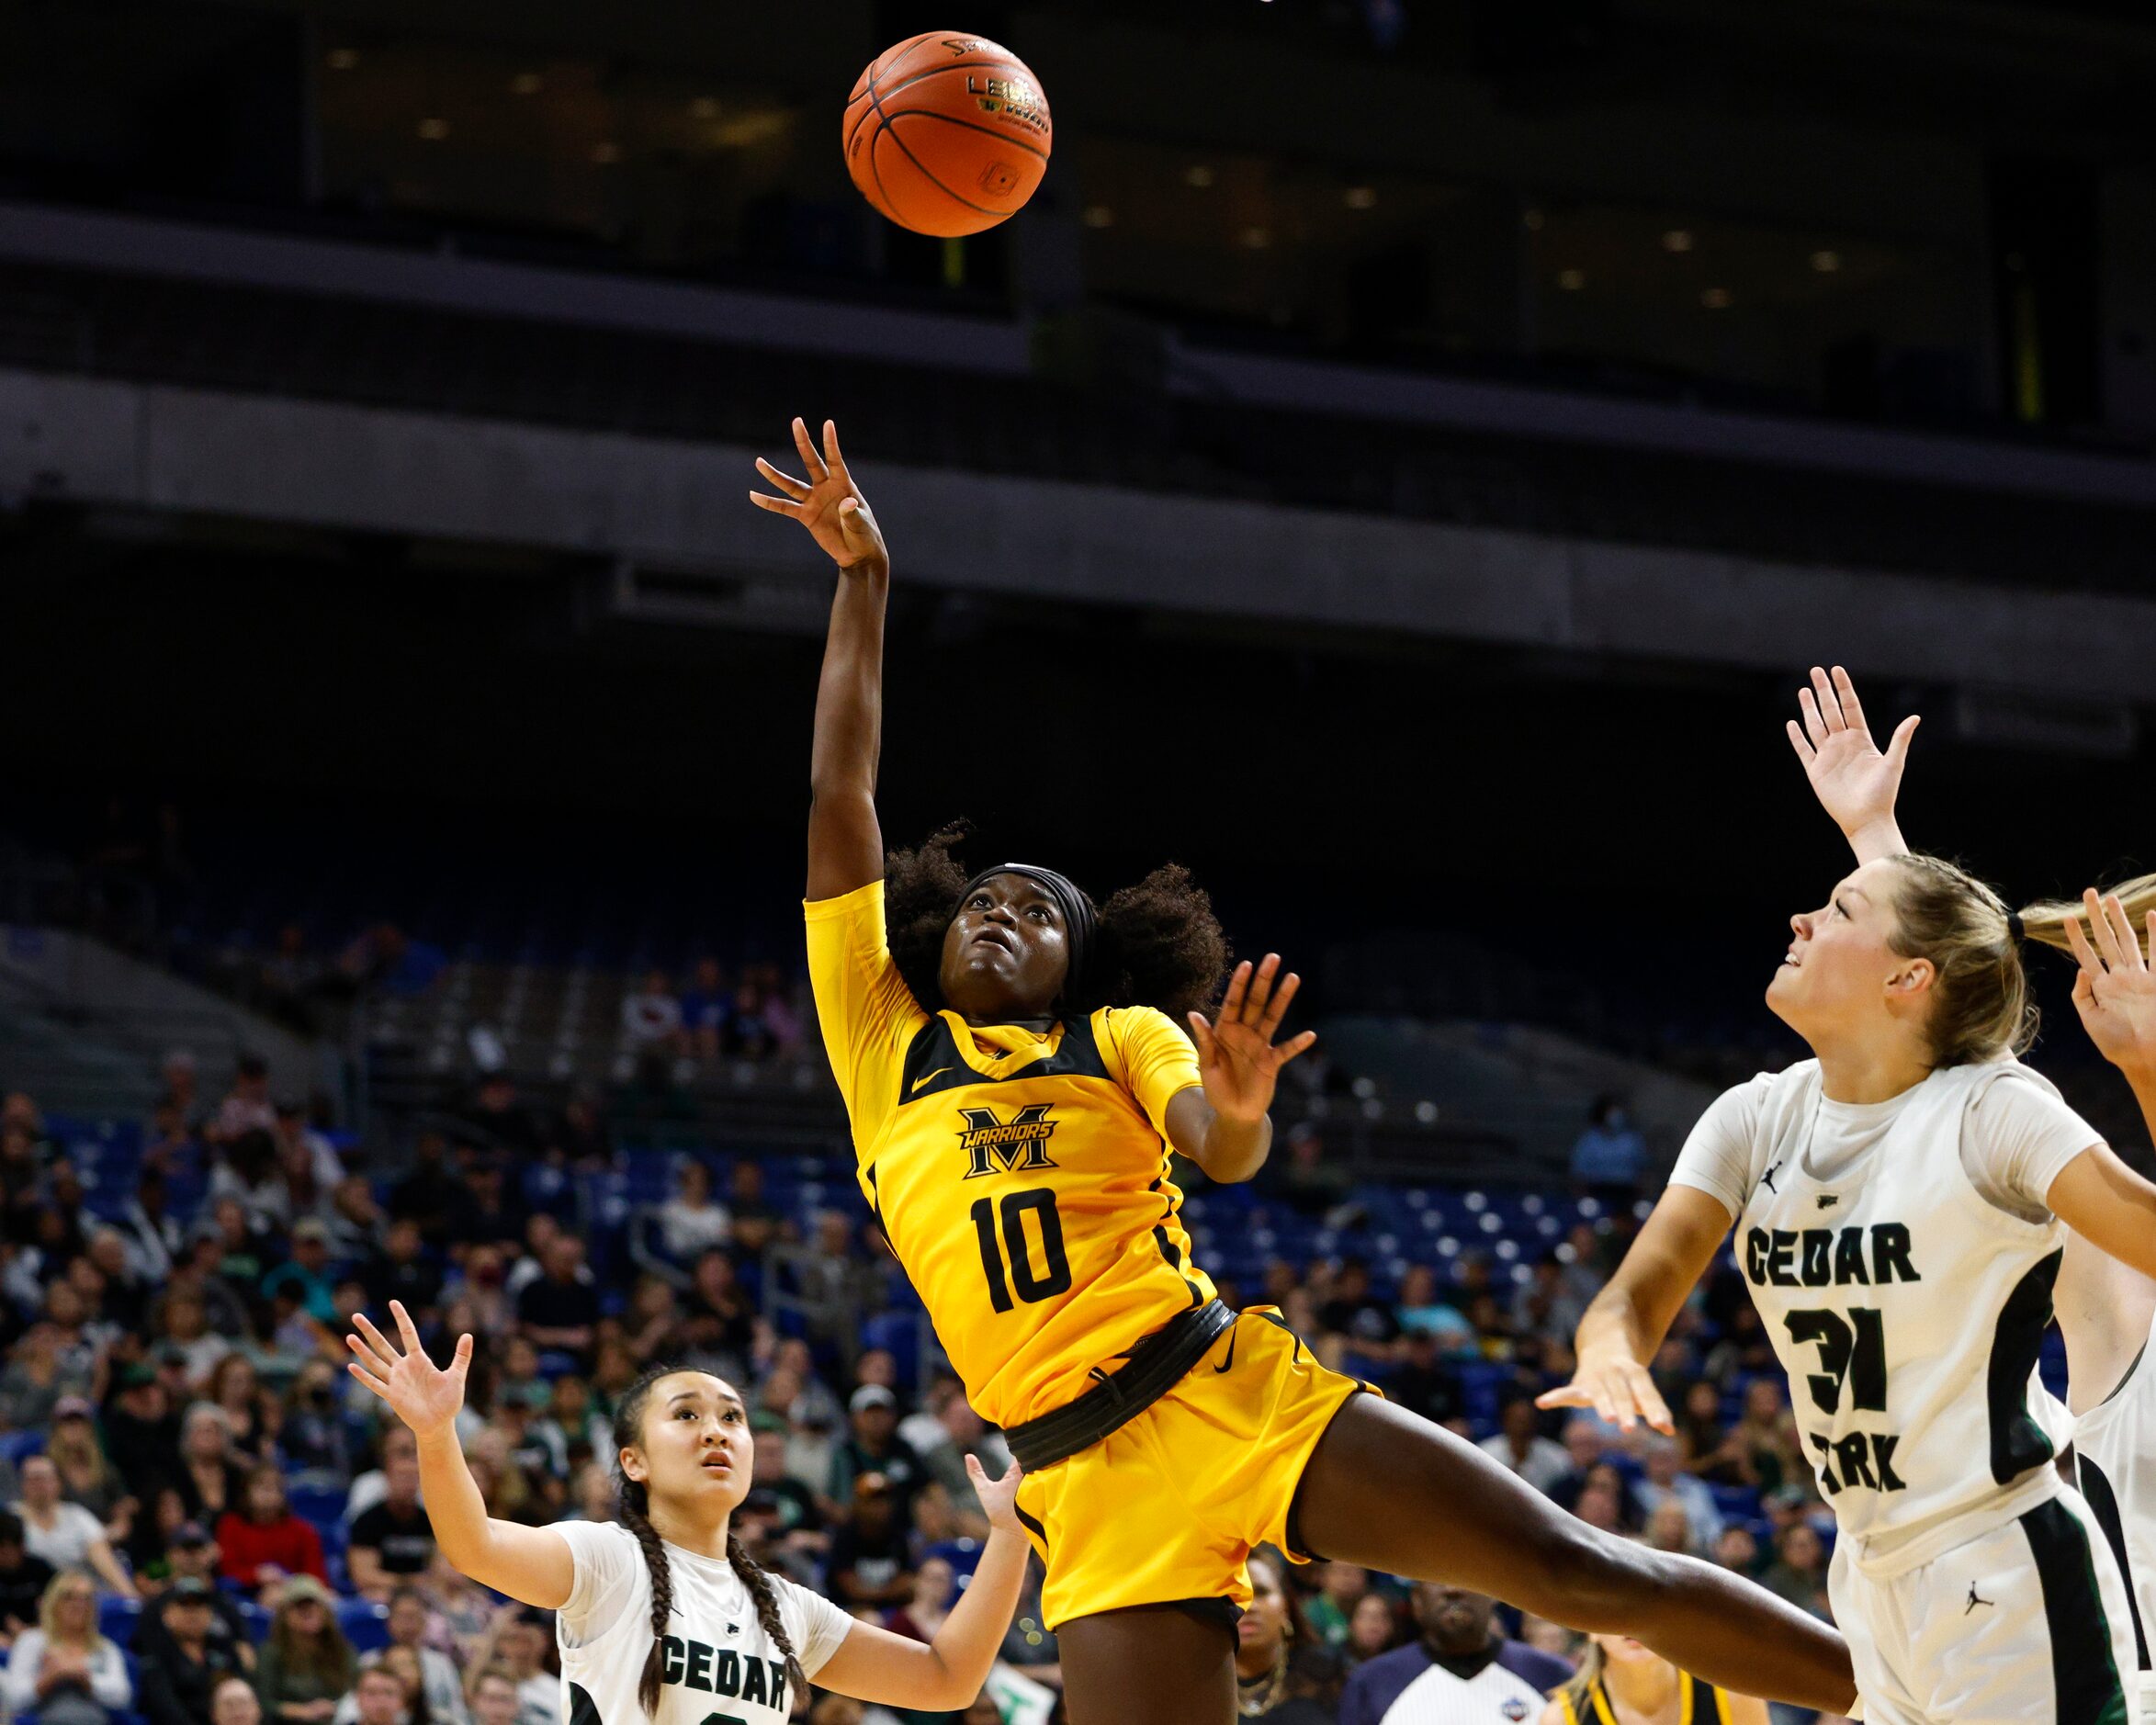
[845,30,1055,240]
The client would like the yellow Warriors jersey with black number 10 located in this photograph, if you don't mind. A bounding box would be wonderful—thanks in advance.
[804,882,1213,1426]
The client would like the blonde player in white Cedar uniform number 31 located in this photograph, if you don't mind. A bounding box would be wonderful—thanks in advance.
[1541,666,2156,1725]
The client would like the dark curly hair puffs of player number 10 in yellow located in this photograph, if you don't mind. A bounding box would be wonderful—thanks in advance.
[884,821,1236,1029]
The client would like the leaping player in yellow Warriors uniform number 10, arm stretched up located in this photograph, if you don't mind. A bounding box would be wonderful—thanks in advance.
[751,421,1857,1725]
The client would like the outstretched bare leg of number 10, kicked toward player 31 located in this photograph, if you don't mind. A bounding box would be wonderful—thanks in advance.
[1284,1395,1857,1725]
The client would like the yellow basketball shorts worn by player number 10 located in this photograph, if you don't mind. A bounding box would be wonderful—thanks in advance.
[1018,1307,1369,1628]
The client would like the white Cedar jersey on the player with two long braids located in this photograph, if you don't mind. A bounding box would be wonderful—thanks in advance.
[554,1522,853,1725]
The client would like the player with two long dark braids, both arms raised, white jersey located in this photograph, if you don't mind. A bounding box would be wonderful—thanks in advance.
[345,1301,1026,1725]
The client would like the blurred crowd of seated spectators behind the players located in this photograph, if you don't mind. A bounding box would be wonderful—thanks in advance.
[0,1065,1854,1725]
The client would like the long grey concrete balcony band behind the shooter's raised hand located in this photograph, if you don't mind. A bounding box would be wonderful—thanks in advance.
[12,371,2156,703]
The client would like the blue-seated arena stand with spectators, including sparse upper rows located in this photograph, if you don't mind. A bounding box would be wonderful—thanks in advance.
[0,815,2095,1725]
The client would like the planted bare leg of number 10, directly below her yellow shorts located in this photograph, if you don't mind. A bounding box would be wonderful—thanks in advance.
[1056,1605,1236,1725]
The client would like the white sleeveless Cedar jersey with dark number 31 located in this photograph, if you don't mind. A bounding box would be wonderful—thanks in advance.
[1735,1061,2065,1539]
